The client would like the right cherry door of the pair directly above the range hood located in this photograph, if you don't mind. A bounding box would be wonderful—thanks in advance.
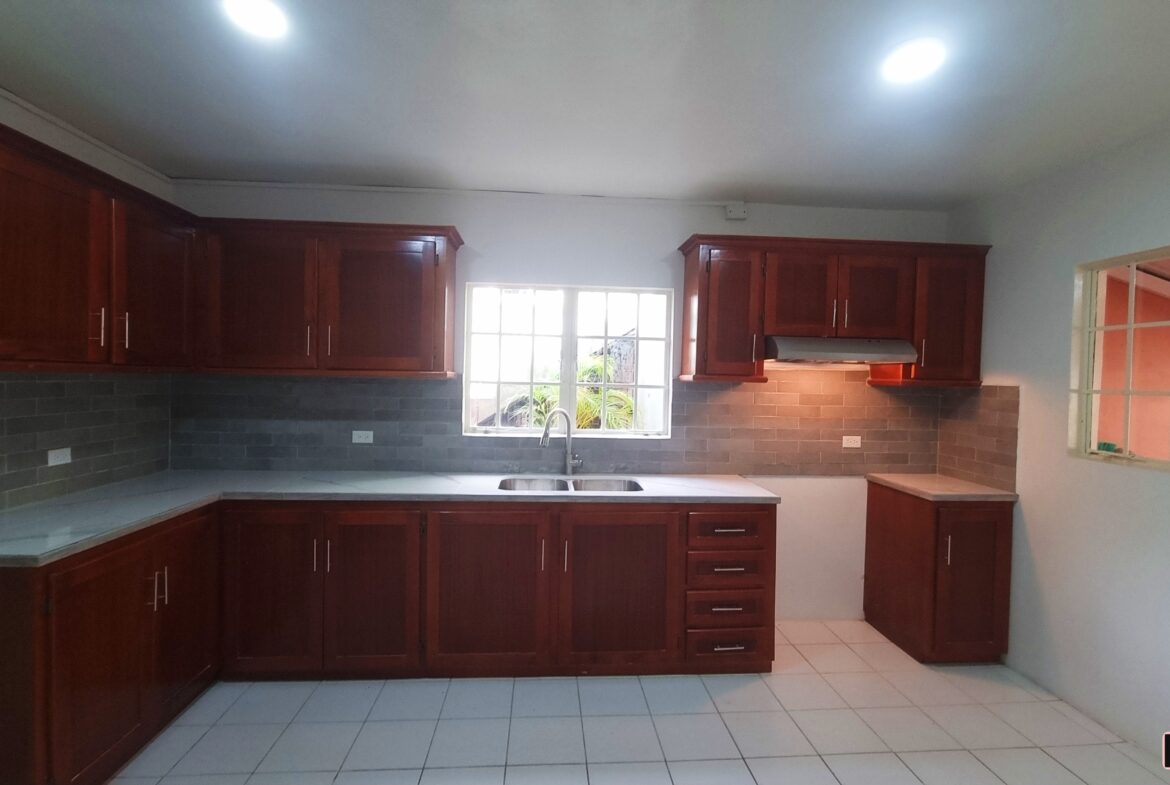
[837,255,914,340]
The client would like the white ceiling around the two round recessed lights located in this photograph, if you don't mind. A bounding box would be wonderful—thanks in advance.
[0,0,1170,207]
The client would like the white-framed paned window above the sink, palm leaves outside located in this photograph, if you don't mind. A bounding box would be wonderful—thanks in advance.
[463,283,674,438]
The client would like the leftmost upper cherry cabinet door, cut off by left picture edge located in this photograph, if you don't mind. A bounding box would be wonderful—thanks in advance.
[0,149,112,363]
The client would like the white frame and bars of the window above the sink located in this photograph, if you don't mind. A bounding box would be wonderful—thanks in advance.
[462,281,674,439]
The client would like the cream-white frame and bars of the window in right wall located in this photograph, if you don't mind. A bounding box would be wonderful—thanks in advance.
[1068,246,1170,471]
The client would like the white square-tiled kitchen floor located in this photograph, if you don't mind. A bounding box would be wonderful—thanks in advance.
[113,621,1170,785]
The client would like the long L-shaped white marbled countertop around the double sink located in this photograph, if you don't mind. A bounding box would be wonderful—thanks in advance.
[0,471,780,567]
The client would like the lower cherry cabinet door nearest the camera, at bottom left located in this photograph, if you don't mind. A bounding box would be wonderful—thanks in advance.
[49,543,150,783]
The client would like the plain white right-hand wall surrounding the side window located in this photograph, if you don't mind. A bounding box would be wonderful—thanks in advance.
[952,127,1170,750]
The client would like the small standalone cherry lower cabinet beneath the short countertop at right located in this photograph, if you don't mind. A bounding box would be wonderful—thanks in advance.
[865,482,1012,662]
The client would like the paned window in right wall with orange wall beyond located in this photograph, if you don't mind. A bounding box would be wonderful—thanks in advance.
[1069,248,1170,469]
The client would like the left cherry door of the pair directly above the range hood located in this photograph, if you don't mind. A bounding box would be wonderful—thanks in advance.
[764,252,837,338]
